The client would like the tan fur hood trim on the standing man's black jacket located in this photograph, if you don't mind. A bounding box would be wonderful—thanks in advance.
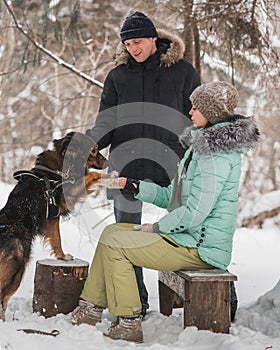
[115,29,185,67]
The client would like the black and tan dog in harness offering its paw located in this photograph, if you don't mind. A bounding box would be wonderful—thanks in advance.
[0,132,106,321]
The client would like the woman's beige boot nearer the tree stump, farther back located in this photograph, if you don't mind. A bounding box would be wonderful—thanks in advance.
[72,299,103,326]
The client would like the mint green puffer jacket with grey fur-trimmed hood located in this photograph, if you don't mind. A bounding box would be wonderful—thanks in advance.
[136,115,259,270]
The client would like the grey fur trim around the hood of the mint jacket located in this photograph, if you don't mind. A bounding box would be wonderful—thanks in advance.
[179,115,260,155]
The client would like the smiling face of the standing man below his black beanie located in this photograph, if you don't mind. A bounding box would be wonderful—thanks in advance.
[124,38,157,62]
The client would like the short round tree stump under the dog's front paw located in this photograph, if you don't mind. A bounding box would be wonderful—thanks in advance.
[33,259,89,317]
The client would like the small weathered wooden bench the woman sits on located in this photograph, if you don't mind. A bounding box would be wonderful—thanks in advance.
[158,269,237,333]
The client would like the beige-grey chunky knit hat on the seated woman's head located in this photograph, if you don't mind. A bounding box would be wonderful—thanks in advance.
[190,81,238,124]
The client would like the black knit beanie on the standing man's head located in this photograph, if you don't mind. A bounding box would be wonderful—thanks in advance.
[120,12,158,42]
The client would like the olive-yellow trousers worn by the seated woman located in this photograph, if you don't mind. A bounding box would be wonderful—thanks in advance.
[81,223,213,317]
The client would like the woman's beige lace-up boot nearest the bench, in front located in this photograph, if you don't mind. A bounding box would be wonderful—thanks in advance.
[104,317,143,343]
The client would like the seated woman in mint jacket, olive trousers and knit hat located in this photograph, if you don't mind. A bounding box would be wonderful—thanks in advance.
[73,82,259,342]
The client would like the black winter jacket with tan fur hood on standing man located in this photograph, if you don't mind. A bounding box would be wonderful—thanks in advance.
[87,30,200,186]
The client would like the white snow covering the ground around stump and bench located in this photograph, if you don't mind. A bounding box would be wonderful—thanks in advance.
[0,182,280,350]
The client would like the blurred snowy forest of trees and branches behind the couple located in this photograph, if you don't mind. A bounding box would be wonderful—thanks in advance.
[0,0,280,226]
